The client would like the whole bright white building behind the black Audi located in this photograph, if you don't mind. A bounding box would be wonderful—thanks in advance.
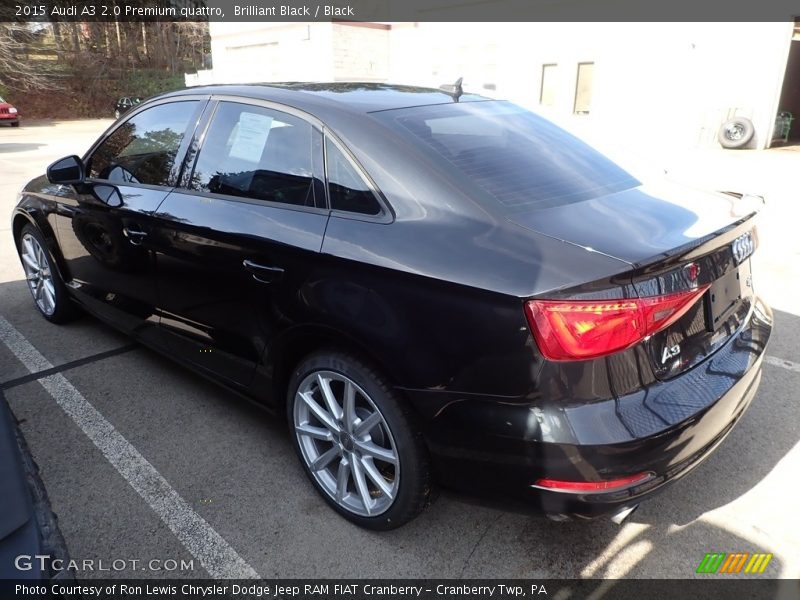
[186,19,800,149]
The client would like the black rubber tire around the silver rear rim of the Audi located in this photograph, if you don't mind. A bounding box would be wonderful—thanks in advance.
[286,351,433,531]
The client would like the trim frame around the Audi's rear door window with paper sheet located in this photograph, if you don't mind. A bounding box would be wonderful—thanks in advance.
[176,94,330,215]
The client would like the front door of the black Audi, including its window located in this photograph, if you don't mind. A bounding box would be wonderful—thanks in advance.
[56,97,207,342]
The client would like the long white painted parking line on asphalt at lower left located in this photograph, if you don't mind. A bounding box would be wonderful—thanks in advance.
[0,316,259,579]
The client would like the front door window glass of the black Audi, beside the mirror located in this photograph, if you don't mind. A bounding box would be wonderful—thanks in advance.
[88,100,198,185]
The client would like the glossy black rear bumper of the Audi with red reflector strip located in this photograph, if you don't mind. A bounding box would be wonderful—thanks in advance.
[406,301,772,518]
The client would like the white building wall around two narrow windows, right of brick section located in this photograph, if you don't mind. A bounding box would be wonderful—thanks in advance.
[390,22,792,148]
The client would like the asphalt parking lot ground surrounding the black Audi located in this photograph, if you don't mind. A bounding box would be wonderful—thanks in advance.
[0,120,800,579]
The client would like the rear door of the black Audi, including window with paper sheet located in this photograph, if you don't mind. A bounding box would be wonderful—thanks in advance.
[156,98,328,387]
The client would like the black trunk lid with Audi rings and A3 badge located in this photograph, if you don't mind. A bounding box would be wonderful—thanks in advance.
[509,184,757,379]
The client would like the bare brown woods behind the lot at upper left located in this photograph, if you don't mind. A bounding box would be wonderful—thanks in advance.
[0,19,209,116]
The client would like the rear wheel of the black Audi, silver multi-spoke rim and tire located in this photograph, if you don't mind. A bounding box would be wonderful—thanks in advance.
[287,352,432,530]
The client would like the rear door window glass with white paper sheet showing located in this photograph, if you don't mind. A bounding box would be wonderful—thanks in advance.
[190,102,315,206]
